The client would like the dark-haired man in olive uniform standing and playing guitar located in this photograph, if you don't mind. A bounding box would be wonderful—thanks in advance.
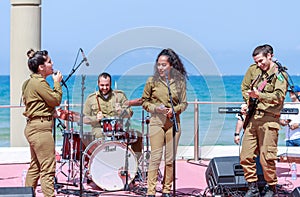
[240,44,287,197]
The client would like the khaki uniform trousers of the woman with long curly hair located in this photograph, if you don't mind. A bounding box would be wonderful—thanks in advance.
[147,123,181,195]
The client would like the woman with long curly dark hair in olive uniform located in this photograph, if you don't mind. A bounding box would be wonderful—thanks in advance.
[142,49,187,197]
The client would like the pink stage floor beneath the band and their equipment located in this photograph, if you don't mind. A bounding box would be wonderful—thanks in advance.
[0,160,300,197]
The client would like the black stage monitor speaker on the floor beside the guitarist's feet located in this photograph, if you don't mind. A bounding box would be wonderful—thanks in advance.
[205,156,266,192]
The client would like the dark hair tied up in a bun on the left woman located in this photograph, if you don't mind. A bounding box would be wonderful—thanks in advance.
[27,49,48,73]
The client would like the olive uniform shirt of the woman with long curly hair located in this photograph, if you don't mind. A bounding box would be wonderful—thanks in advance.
[142,77,188,126]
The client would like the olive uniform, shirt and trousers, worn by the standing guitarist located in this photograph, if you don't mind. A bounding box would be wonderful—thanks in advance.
[240,64,287,185]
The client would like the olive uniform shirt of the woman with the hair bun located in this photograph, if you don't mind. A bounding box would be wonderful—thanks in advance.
[22,74,62,118]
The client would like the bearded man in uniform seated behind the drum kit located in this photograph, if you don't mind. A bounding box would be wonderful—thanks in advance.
[83,72,142,159]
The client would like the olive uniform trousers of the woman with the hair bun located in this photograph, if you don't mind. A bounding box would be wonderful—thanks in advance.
[24,119,56,197]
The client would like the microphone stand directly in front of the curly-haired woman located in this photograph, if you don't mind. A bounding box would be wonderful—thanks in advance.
[166,73,178,197]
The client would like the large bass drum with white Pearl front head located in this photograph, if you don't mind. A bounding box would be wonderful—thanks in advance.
[83,140,138,191]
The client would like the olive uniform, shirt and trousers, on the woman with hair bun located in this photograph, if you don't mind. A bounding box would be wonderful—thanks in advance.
[22,74,62,197]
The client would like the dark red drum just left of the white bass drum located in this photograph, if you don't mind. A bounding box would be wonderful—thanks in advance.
[62,131,85,160]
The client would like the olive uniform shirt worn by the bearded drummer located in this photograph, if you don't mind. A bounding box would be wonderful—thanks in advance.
[83,90,142,159]
